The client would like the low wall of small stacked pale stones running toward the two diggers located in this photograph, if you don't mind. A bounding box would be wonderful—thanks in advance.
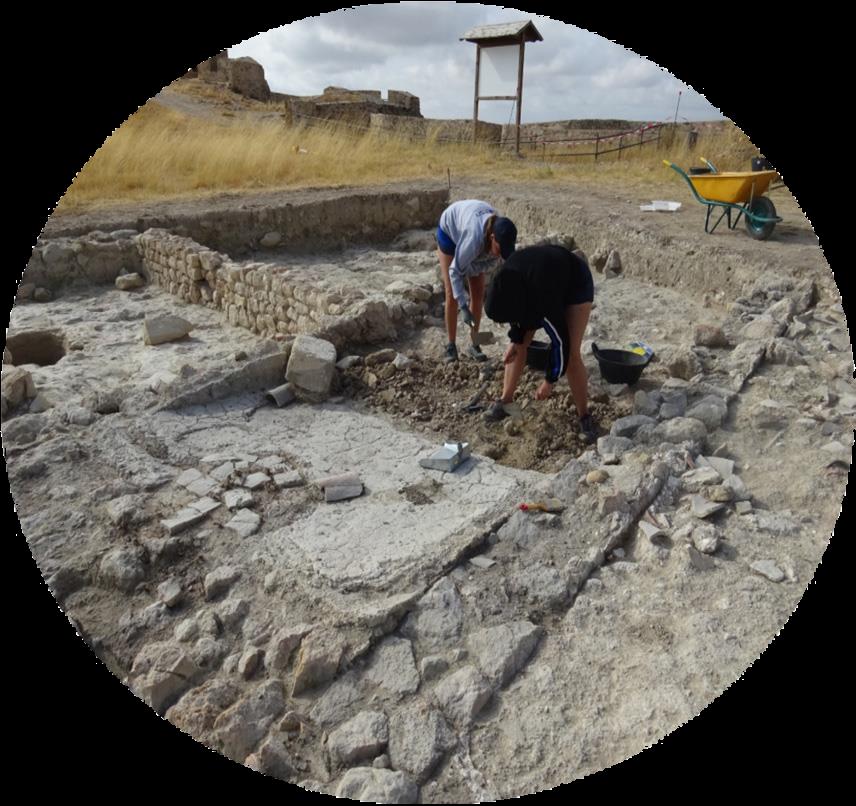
[137,229,430,348]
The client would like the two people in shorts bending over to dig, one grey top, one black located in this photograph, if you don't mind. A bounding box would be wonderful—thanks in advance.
[437,199,597,442]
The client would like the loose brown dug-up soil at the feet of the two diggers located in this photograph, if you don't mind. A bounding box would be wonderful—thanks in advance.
[340,354,630,473]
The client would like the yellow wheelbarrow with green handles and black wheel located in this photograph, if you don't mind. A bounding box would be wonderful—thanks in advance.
[663,159,782,241]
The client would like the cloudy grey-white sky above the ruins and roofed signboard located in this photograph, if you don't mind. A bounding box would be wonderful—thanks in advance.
[229,2,723,123]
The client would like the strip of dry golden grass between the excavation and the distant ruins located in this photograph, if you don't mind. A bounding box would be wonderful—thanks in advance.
[57,96,757,214]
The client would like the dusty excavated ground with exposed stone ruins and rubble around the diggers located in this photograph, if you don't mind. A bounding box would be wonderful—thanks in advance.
[2,181,856,803]
